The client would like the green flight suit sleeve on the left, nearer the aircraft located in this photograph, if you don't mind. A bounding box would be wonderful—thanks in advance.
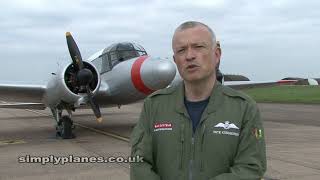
[130,101,160,180]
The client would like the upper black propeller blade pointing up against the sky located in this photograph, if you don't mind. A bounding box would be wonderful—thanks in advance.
[66,32,83,70]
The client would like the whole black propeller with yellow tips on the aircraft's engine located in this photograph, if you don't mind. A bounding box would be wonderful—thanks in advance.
[66,32,102,122]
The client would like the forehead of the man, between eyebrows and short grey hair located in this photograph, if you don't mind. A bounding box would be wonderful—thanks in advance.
[172,26,212,47]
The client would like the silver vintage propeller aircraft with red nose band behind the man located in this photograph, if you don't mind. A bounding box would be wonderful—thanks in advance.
[0,32,176,139]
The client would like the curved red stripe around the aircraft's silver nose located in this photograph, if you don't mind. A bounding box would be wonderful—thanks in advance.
[131,56,155,95]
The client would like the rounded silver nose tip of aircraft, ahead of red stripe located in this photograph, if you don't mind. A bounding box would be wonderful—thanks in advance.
[141,59,176,90]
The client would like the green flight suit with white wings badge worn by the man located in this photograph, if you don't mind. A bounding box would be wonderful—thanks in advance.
[130,81,266,180]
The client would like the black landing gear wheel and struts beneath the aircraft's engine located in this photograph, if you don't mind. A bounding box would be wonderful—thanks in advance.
[51,109,75,139]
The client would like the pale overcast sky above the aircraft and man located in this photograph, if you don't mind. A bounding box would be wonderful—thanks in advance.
[0,0,320,83]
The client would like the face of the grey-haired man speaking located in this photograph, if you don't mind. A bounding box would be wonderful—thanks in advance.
[172,26,221,82]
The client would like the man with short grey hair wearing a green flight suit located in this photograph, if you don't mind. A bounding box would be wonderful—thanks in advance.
[130,21,266,180]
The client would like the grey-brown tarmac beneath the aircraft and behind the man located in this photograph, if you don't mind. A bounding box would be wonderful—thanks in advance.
[0,103,320,180]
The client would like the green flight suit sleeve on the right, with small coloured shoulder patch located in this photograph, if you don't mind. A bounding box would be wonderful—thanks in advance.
[210,103,267,180]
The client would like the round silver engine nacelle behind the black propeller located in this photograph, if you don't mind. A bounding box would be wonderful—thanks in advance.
[45,61,101,107]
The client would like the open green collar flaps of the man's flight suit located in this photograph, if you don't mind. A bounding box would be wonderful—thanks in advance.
[176,81,223,116]
